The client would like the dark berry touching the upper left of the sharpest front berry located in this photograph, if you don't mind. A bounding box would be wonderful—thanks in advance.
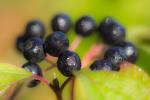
[44,32,69,57]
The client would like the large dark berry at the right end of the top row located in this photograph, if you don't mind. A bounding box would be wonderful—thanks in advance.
[99,17,125,44]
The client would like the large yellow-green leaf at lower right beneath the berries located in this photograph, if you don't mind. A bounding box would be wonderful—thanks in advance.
[74,65,150,100]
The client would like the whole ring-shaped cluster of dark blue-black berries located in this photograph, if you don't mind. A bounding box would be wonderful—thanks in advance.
[16,14,137,87]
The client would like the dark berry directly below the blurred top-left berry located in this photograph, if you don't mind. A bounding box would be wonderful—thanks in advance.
[23,37,45,62]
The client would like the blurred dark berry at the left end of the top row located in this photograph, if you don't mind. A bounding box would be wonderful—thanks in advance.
[25,20,45,38]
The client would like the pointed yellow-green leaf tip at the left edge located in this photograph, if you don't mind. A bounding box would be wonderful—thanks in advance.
[0,63,32,93]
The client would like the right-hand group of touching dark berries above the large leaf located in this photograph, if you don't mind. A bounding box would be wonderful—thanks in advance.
[90,17,138,71]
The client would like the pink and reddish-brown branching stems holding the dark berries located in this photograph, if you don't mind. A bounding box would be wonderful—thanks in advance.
[7,36,105,100]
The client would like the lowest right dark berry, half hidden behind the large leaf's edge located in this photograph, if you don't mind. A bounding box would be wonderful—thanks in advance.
[90,60,113,71]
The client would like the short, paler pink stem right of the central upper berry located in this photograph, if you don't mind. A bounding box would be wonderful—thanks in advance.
[69,36,82,51]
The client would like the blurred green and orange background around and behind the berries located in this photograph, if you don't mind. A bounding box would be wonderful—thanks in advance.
[0,0,150,100]
